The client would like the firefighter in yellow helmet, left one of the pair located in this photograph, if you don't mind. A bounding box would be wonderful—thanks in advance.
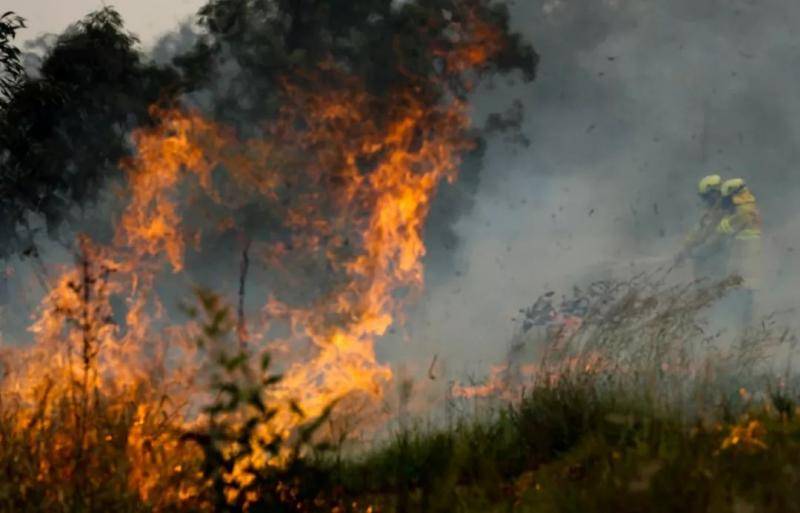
[675,175,727,281]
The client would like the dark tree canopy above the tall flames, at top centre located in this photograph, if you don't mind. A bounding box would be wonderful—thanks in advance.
[176,0,538,120]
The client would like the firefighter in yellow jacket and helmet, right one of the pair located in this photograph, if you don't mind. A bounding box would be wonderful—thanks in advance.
[717,178,762,326]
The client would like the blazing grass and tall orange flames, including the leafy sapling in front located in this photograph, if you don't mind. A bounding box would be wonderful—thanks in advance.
[0,14,502,511]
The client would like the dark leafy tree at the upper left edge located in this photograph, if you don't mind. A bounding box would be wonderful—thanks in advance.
[0,7,176,256]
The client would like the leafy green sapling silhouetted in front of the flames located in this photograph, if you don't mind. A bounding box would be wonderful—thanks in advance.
[182,290,333,513]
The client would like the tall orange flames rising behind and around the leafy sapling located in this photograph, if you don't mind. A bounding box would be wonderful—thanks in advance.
[4,7,500,502]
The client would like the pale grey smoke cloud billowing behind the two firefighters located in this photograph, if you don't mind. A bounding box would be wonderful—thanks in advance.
[384,0,800,376]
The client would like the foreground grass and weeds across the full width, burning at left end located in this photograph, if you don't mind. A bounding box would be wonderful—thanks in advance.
[0,270,800,512]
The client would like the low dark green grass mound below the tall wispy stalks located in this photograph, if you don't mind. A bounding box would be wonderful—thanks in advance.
[320,376,800,513]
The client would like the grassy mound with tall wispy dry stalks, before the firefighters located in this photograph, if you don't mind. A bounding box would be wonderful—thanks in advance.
[318,271,800,512]
